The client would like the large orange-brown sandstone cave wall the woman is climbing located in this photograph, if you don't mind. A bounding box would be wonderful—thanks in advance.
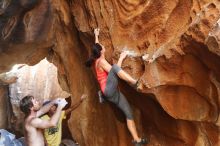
[0,0,220,146]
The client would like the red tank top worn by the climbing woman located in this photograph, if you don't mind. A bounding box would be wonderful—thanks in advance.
[95,59,108,93]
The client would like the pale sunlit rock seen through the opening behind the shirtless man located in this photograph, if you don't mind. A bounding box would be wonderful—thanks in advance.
[8,59,70,131]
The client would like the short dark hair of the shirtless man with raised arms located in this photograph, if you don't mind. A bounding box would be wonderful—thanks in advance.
[20,95,34,116]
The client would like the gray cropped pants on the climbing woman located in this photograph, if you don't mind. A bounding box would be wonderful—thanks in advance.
[104,64,134,120]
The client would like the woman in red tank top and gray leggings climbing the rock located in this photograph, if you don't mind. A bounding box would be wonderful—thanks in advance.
[86,29,147,146]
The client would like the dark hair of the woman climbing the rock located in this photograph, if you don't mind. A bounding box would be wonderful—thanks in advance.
[86,43,102,67]
